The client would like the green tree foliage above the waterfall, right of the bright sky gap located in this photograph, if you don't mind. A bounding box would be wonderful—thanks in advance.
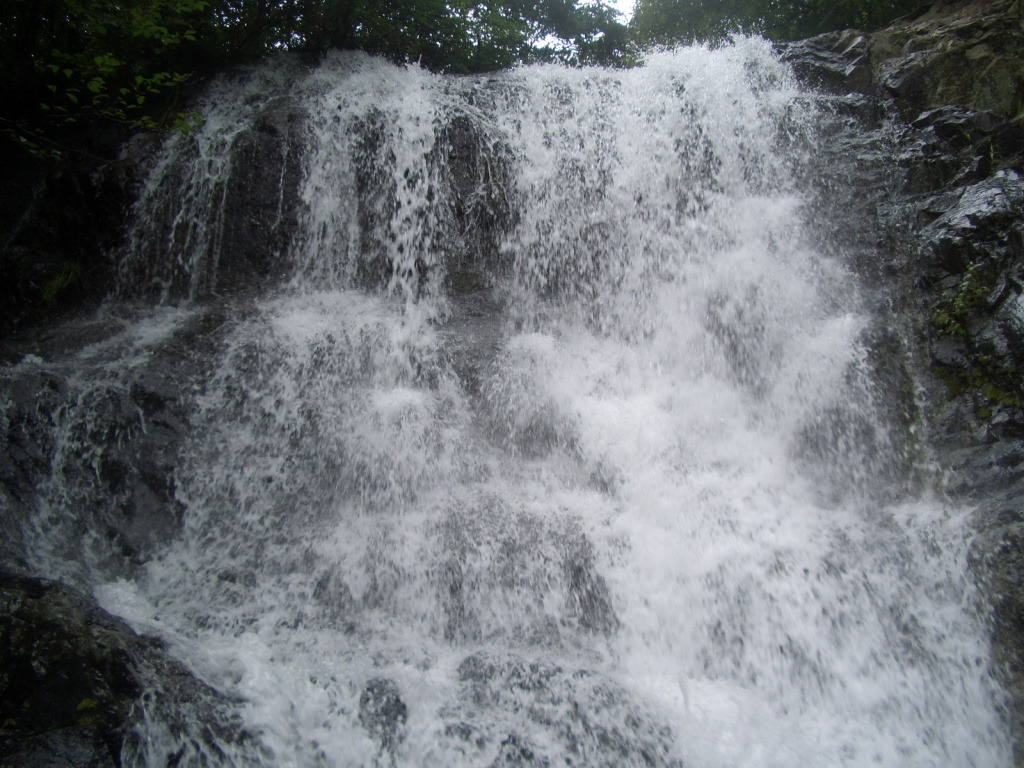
[632,0,926,45]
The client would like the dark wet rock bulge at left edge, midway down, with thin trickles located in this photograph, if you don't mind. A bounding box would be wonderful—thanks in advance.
[0,307,230,575]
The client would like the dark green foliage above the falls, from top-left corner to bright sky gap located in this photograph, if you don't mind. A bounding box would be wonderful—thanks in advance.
[0,0,628,157]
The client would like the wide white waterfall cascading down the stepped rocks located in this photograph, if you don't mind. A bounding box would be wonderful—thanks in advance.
[4,40,1010,767]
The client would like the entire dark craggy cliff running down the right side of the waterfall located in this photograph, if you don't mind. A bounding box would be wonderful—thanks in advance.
[786,0,1024,765]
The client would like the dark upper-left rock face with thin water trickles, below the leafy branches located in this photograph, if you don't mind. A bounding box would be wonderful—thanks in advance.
[115,97,307,301]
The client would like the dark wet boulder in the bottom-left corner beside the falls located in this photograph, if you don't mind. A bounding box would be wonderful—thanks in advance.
[0,572,258,768]
